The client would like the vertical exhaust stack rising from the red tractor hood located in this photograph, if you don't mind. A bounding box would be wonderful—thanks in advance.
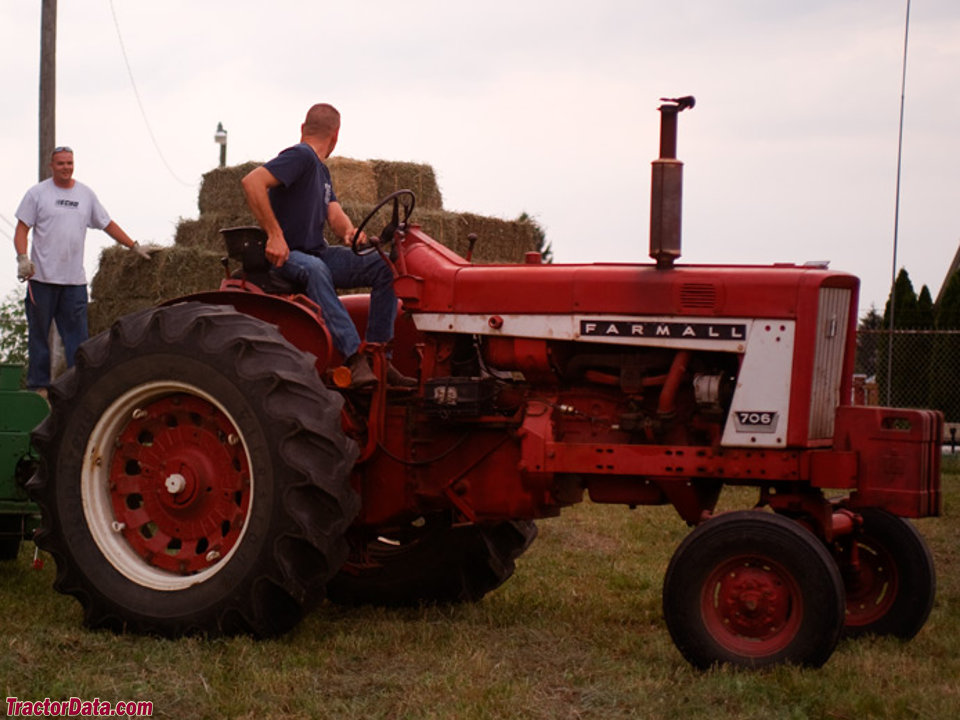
[650,95,696,270]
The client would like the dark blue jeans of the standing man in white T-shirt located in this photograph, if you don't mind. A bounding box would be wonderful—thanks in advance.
[24,280,88,388]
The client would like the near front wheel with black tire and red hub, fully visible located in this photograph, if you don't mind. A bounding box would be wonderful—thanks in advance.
[663,510,844,668]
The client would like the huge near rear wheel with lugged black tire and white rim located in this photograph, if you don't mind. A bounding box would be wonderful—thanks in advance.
[28,303,359,636]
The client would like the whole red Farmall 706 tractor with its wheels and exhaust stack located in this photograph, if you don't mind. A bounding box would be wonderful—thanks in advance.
[30,98,942,667]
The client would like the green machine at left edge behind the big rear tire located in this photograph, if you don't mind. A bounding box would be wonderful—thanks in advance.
[0,364,50,560]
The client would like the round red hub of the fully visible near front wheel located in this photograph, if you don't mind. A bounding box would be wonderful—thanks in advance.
[700,557,803,656]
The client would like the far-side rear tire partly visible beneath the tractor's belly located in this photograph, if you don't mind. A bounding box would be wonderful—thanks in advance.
[328,520,537,607]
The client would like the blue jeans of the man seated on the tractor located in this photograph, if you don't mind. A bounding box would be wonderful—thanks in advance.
[279,245,397,358]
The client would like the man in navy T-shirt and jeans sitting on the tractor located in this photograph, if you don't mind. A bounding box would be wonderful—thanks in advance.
[242,103,416,387]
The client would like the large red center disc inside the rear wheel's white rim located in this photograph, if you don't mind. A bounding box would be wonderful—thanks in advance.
[110,394,251,575]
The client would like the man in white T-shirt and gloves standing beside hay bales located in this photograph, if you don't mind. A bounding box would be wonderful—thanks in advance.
[13,146,150,393]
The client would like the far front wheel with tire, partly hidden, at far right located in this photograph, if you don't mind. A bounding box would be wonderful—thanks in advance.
[841,509,937,640]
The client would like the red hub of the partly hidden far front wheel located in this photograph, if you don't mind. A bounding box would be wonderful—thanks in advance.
[844,538,900,627]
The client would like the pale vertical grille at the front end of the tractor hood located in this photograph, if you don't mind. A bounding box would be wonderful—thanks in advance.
[808,288,851,440]
